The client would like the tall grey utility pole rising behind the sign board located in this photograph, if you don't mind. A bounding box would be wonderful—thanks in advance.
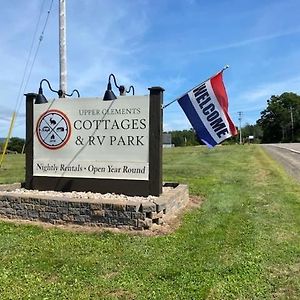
[59,0,67,97]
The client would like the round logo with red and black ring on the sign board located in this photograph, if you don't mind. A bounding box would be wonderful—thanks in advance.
[36,109,71,150]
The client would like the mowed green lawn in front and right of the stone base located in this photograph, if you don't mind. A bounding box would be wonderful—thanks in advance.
[0,145,300,299]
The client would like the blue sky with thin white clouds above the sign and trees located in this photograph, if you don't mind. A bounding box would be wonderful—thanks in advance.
[0,0,300,137]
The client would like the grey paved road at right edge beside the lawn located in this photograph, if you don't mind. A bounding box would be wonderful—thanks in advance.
[262,143,300,181]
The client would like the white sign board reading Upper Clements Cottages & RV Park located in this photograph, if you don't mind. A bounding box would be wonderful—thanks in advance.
[33,96,149,180]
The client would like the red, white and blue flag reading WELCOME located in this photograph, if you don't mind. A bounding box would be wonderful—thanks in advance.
[178,71,237,147]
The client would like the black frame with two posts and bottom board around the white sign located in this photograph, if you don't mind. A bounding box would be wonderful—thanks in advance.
[24,87,164,196]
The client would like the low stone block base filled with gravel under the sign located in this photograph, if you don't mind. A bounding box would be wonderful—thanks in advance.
[0,183,189,230]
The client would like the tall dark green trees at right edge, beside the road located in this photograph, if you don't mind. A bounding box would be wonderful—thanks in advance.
[257,93,300,143]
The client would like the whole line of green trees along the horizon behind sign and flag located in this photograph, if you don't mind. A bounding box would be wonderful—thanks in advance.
[0,92,300,153]
